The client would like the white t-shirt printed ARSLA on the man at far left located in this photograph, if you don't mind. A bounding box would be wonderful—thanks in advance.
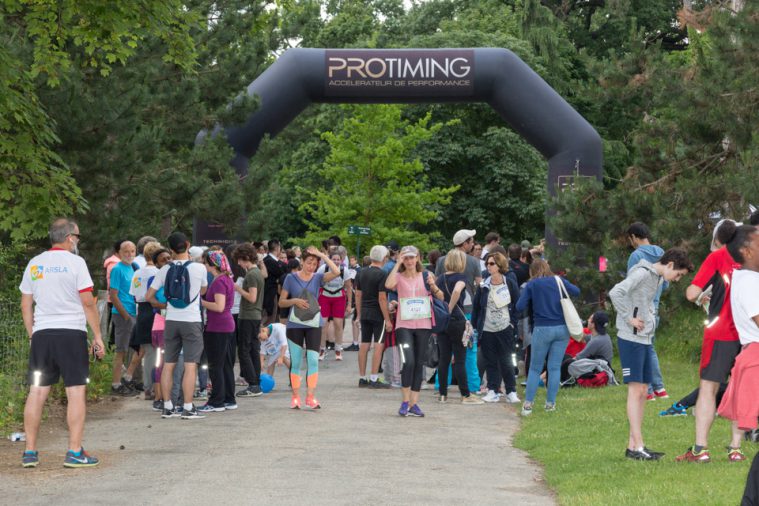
[18,249,93,332]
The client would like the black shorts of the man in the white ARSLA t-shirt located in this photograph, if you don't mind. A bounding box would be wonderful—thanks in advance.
[28,329,90,387]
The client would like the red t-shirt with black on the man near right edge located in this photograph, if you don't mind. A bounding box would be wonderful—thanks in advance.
[692,247,740,341]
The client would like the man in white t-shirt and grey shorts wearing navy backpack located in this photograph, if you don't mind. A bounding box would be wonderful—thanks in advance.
[145,232,208,420]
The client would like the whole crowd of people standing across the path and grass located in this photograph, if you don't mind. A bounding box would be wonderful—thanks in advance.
[14,213,759,500]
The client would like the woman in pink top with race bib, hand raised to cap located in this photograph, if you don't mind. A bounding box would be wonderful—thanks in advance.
[385,246,443,416]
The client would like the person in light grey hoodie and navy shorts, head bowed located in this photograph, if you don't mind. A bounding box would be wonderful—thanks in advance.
[609,248,691,460]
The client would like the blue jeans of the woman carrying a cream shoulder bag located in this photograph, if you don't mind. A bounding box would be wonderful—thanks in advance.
[525,325,569,404]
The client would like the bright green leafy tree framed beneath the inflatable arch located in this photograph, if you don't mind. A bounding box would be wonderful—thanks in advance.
[299,105,458,253]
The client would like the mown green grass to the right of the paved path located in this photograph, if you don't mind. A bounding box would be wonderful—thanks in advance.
[515,311,759,506]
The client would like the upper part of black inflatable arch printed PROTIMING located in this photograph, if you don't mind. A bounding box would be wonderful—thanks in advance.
[221,48,603,193]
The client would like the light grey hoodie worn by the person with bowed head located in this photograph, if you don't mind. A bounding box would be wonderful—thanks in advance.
[609,260,664,344]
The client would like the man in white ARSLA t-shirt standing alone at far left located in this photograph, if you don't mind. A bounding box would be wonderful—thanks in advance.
[19,218,105,467]
